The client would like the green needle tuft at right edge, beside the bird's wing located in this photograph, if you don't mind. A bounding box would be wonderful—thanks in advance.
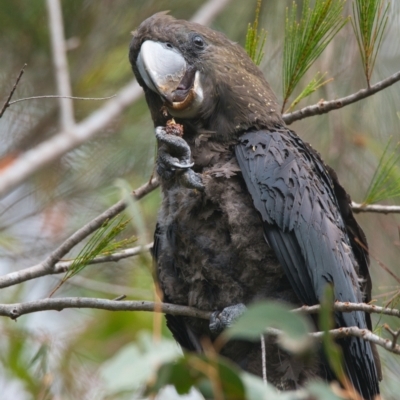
[363,138,400,204]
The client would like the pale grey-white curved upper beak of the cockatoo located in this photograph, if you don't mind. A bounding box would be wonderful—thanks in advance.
[136,40,187,103]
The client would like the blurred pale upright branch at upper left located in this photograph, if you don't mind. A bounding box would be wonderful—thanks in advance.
[47,0,75,131]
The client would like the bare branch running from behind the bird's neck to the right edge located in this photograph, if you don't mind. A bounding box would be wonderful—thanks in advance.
[283,71,400,125]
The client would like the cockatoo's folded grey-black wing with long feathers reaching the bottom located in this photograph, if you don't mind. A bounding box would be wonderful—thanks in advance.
[235,128,379,398]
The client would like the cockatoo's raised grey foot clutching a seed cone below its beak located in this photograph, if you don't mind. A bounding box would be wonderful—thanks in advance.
[156,126,204,190]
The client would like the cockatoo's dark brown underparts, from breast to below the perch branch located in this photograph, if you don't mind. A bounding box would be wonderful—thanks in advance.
[155,127,325,389]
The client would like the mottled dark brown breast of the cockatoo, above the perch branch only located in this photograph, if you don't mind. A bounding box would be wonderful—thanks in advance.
[158,158,296,310]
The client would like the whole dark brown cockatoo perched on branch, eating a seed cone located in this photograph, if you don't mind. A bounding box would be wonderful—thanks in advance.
[129,13,380,399]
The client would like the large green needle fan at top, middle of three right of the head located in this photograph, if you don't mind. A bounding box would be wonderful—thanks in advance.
[282,0,348,111]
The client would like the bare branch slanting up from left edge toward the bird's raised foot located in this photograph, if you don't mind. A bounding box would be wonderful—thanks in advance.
[0,178,158,288]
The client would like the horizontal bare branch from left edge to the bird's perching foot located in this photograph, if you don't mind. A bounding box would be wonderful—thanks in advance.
[0,297,211,319]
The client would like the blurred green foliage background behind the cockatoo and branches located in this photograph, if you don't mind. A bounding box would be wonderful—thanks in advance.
[0,0,400,399]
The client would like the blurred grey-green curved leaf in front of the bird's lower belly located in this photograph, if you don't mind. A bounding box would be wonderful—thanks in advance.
[224,301,312,353]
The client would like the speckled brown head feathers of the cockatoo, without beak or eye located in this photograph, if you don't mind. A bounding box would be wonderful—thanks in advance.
[129,12,283,140]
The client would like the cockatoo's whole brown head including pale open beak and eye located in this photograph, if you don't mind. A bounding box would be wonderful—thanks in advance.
[129,13,282,140]
